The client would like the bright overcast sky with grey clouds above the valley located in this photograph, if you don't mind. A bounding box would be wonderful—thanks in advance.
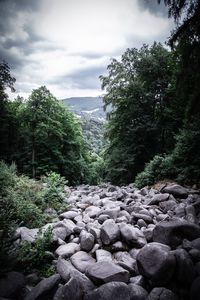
[0,0,172,99]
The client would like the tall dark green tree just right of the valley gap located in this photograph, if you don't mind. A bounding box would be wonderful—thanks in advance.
[100,43,177,183]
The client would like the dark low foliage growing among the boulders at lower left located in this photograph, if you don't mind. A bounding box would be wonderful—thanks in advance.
[15,227,54,277]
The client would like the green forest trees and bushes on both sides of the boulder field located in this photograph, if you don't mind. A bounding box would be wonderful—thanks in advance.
[0,0,200,299]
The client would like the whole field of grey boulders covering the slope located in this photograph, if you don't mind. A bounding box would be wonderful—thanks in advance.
[0,184,200,300]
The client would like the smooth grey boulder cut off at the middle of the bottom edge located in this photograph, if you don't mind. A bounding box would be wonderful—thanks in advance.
[84,282,131,300]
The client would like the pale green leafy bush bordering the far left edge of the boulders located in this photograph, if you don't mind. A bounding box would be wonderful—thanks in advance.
[42,172,67,210]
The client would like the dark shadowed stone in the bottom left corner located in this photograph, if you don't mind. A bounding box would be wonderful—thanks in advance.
[0,272,26,299]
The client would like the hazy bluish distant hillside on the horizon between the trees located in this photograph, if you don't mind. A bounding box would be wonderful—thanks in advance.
[62,97,106,119]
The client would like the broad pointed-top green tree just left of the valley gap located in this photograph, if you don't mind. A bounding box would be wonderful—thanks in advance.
[17,86,90,184]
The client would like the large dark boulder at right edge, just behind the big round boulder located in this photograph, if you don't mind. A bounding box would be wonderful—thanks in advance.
[153,220,200,248]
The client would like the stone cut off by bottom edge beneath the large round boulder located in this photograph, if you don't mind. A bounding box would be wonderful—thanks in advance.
[147,287,178,300]
